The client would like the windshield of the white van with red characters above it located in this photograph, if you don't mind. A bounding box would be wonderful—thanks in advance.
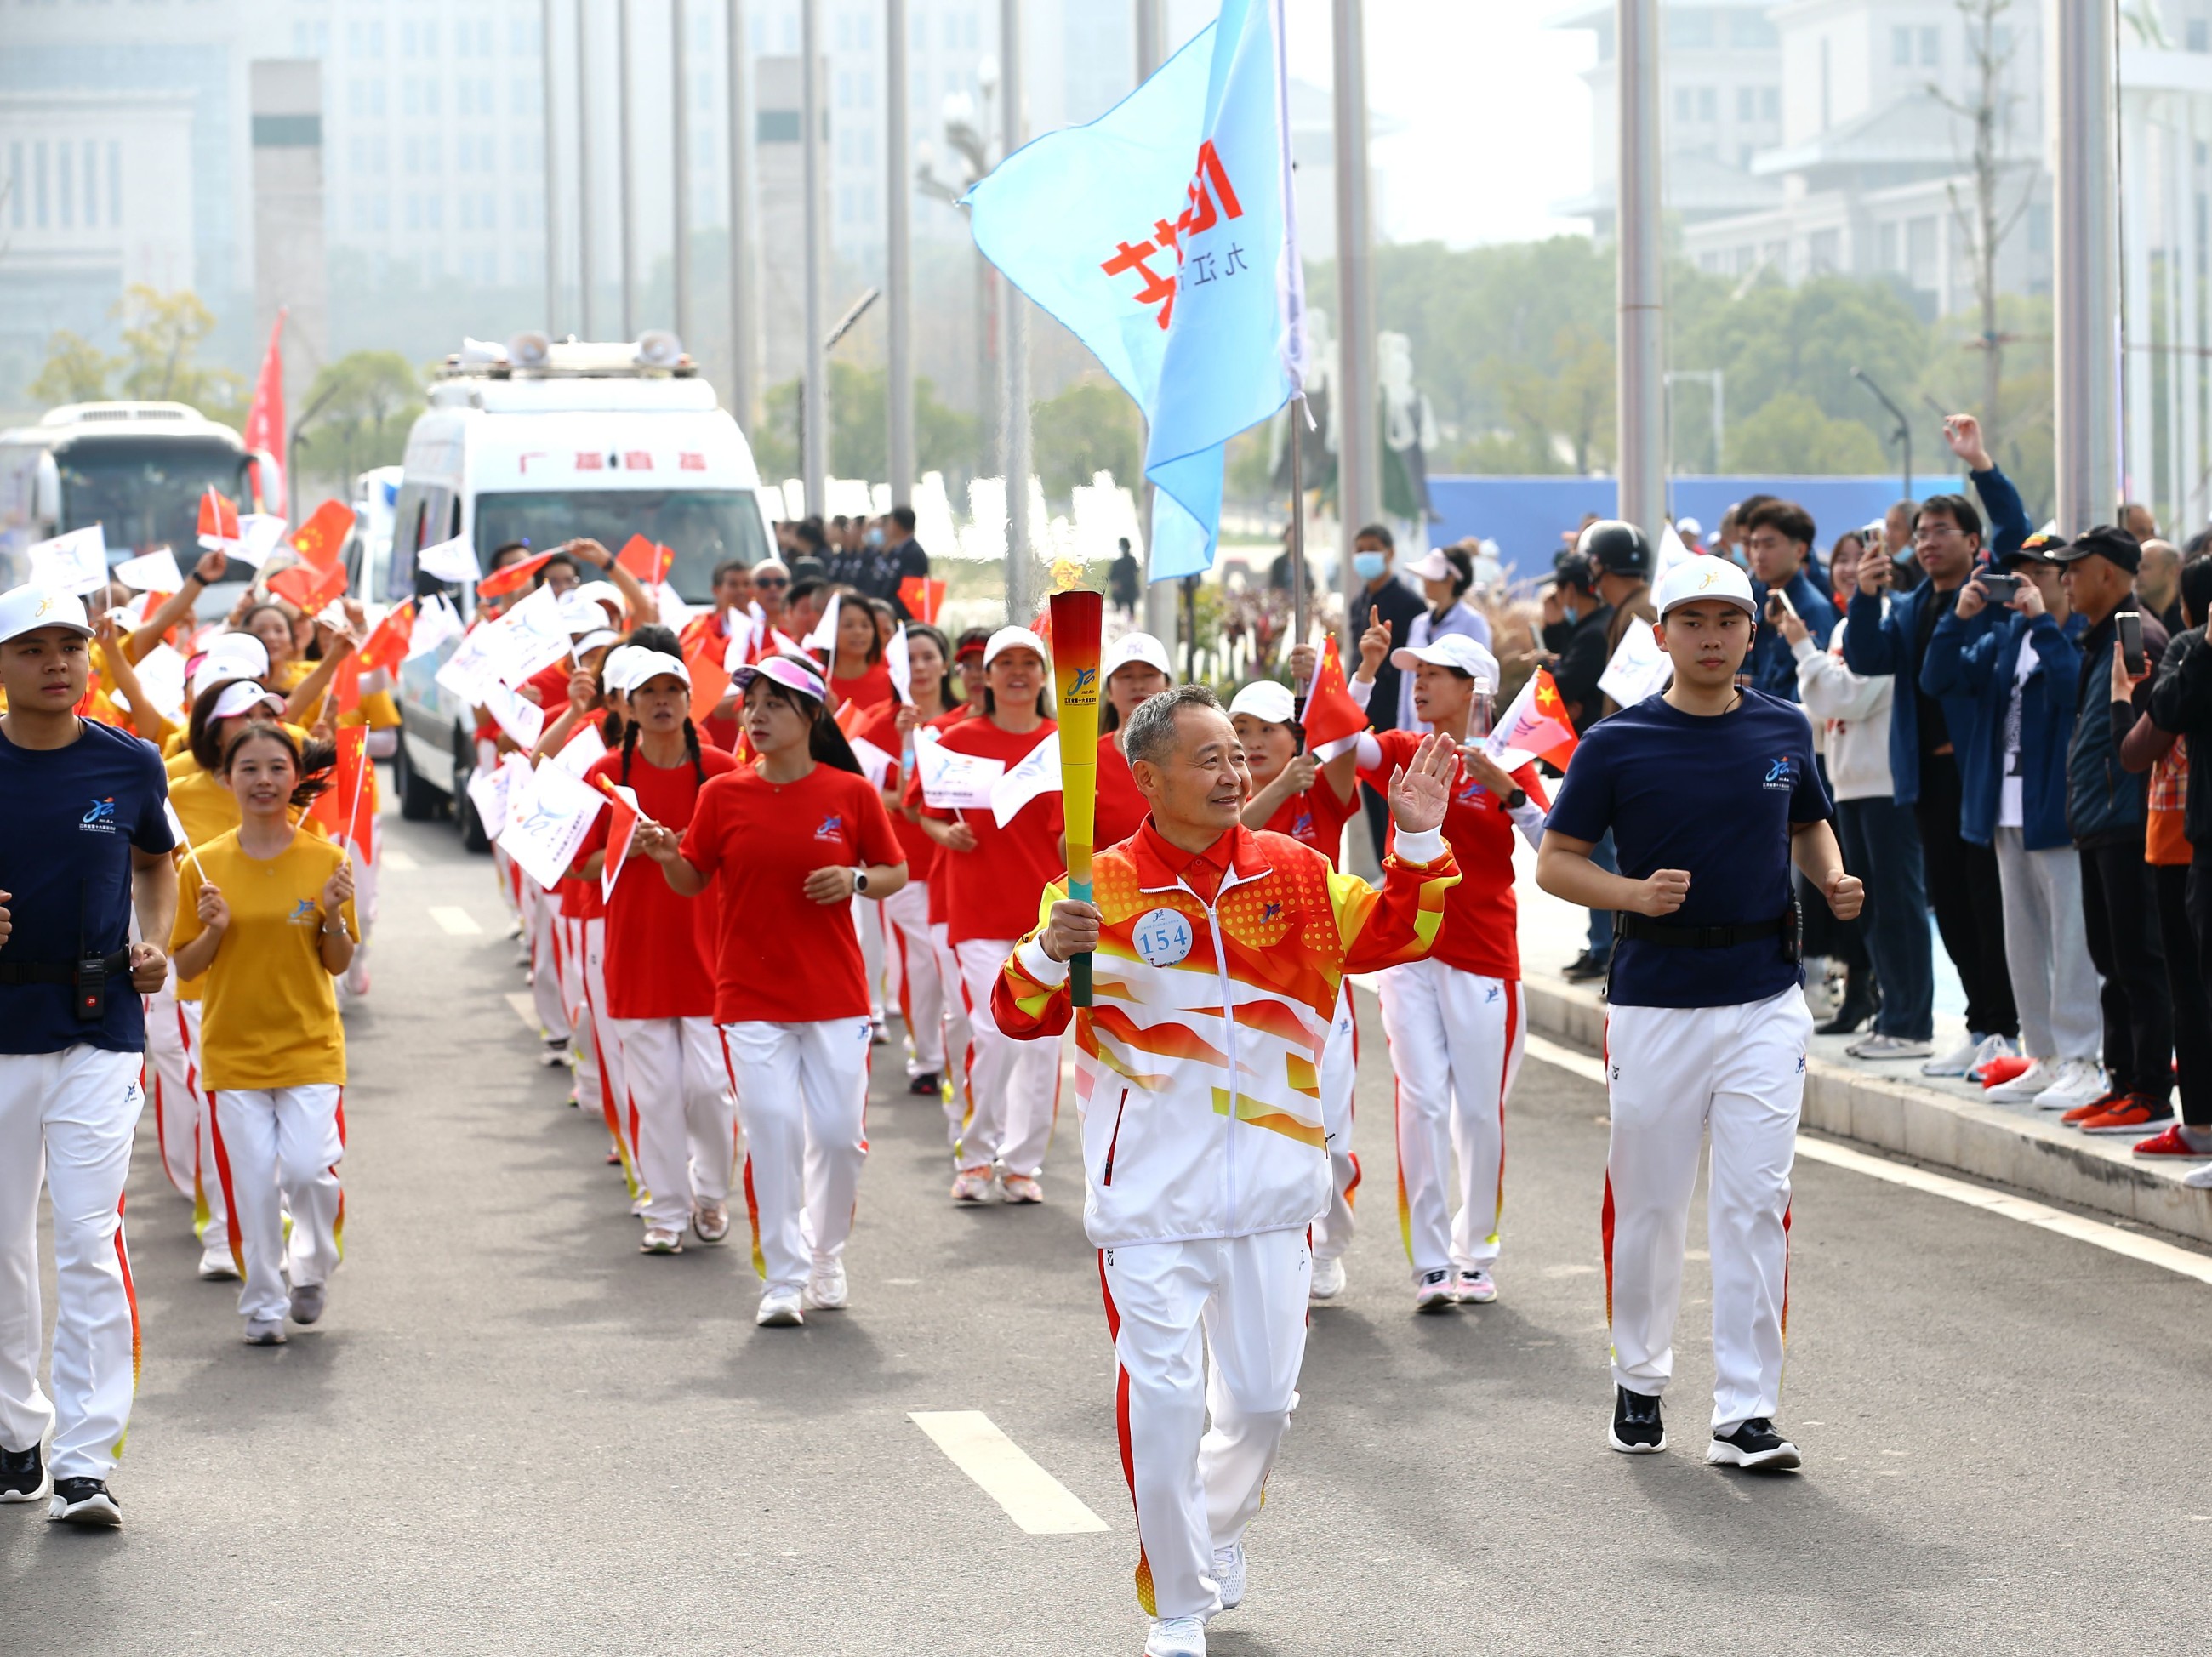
[476,489,767,604]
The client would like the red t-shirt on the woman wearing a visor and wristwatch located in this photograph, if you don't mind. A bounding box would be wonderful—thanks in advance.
[681,766,900,1024]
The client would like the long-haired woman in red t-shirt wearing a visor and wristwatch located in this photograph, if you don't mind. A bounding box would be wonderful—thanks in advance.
[637,657,907,1327]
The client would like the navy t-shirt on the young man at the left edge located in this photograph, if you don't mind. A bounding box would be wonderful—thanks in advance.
[0,719,174,1053]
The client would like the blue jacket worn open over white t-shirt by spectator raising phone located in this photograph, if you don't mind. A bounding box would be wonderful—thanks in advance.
[1920,612,2086,851]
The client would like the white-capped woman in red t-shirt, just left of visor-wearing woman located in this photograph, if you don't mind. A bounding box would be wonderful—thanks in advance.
[578,641,737,1255]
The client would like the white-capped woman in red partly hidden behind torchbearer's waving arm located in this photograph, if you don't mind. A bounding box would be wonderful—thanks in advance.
[1230,668,1360,1301]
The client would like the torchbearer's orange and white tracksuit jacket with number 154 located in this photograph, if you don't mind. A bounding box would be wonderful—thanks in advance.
[991,825,1460,1248]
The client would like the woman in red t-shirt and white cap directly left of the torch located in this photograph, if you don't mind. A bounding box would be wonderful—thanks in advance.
[907,626,1066,1204]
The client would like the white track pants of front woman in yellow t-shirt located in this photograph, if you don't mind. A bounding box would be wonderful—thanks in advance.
[208,1082,345,1318]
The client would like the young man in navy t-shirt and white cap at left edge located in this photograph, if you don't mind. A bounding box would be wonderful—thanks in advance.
[0,586,177,1524]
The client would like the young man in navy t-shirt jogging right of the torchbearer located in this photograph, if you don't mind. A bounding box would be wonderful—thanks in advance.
[1537,557,1862,1469]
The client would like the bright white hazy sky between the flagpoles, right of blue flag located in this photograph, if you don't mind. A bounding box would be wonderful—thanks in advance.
[1170,0,1597,248]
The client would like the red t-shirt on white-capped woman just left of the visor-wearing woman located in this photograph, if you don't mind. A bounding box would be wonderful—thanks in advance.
[578,745,737,1017]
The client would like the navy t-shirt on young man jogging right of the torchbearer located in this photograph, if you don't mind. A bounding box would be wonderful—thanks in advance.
[1544,690,1829,1006]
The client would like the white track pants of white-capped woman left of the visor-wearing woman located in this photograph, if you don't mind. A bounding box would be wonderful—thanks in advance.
[615,1017,737,1233]
